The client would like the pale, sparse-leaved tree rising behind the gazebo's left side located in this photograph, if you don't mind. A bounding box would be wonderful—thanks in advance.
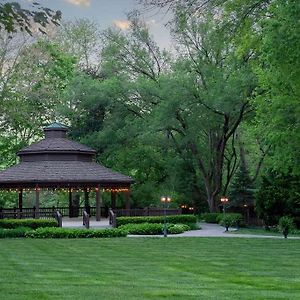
[0,35,74,167]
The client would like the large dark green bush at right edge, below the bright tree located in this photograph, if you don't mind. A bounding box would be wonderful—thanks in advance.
[255,171,300,226]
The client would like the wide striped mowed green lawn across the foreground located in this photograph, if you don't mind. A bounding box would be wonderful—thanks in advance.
[0,238,300,300]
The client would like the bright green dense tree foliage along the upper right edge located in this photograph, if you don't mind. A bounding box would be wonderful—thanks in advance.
[254,0,300,175]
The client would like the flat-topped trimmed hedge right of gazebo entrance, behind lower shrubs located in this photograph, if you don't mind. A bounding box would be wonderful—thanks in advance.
[117,215,197,227]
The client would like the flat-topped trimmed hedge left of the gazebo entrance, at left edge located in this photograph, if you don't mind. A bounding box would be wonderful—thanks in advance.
[0,219,58,229]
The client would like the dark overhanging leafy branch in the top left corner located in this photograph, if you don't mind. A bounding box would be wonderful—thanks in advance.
[0,2,61,34]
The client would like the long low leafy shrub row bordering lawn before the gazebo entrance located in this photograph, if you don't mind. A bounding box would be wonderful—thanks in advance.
[25,227,127,239]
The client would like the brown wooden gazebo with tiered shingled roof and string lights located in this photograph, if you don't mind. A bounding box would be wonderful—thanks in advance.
[0,123,134,221]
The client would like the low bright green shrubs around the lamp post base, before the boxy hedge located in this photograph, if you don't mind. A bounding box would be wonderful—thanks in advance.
[118,223,190,235]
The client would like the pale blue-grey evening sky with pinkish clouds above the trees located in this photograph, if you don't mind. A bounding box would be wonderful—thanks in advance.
[15,0,171,49]
